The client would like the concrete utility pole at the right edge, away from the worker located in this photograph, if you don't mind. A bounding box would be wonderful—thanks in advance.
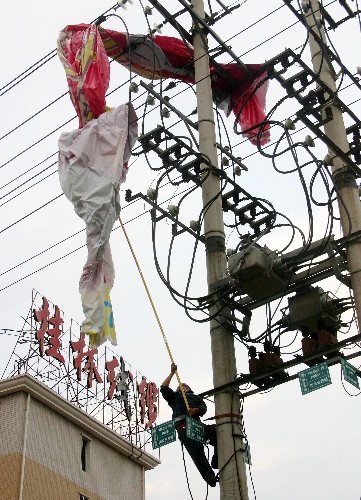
[305,0,361,328]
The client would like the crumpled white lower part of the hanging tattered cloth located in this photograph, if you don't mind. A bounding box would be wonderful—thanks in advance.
[58,105,138,345]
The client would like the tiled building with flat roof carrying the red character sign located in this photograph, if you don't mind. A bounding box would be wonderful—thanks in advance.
[0,375,159,500]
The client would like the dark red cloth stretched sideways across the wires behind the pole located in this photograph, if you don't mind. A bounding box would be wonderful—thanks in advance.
[59,24,269,145]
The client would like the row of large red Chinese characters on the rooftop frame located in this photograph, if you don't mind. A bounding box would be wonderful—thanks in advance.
[31,297,158,430]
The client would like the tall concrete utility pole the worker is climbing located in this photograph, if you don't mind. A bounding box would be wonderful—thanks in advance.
[192,0,248,500]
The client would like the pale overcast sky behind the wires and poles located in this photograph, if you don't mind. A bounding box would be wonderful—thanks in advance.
[0,0,361,500]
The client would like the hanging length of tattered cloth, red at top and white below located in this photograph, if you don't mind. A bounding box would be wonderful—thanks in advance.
[58,25,138,346]
